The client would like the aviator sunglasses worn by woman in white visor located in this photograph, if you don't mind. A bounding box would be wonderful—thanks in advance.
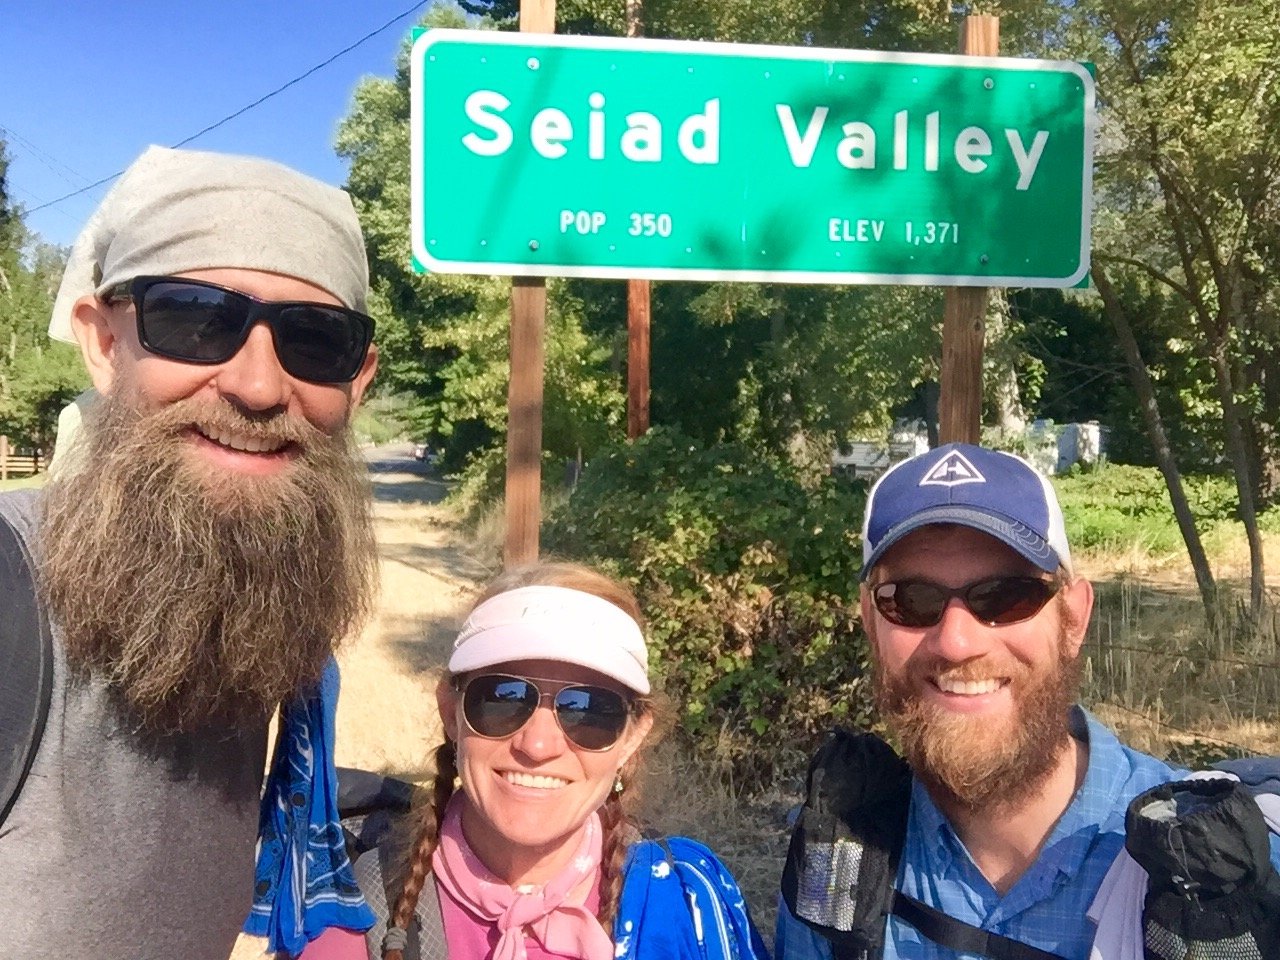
[462,673,631,751]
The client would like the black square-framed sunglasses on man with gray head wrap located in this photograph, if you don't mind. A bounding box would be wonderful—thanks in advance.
[105,276,374,383]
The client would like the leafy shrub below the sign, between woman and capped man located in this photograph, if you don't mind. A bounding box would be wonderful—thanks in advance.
[544,429,869,782]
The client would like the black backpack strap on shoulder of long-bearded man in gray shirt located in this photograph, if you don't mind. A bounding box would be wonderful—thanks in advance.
[0,516,54,824]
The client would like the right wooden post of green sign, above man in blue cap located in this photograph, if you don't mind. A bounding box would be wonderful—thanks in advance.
[938,14,1000,443]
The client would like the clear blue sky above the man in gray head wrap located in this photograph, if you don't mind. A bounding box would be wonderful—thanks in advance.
[0,0,426,244]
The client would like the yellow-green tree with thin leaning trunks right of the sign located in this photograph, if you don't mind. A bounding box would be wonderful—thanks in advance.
[1070,0,1280,612]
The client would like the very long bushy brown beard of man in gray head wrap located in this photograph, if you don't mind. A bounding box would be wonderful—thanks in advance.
[40,394,376,732]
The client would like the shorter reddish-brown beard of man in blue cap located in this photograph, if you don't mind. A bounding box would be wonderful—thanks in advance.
[874,627,1080,810]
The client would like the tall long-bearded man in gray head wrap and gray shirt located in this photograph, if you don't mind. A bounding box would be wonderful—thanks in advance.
[0,147,378,960]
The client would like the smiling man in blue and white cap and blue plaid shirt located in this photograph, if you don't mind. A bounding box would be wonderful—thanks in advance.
[777,444,1280,960]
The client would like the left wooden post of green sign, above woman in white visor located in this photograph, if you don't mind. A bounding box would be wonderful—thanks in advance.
[503,0,556,567]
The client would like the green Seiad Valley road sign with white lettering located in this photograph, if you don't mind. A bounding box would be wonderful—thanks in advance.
[411,29,1094,287]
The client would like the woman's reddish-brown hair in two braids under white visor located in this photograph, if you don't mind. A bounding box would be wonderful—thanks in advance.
[383,562,657,960]
